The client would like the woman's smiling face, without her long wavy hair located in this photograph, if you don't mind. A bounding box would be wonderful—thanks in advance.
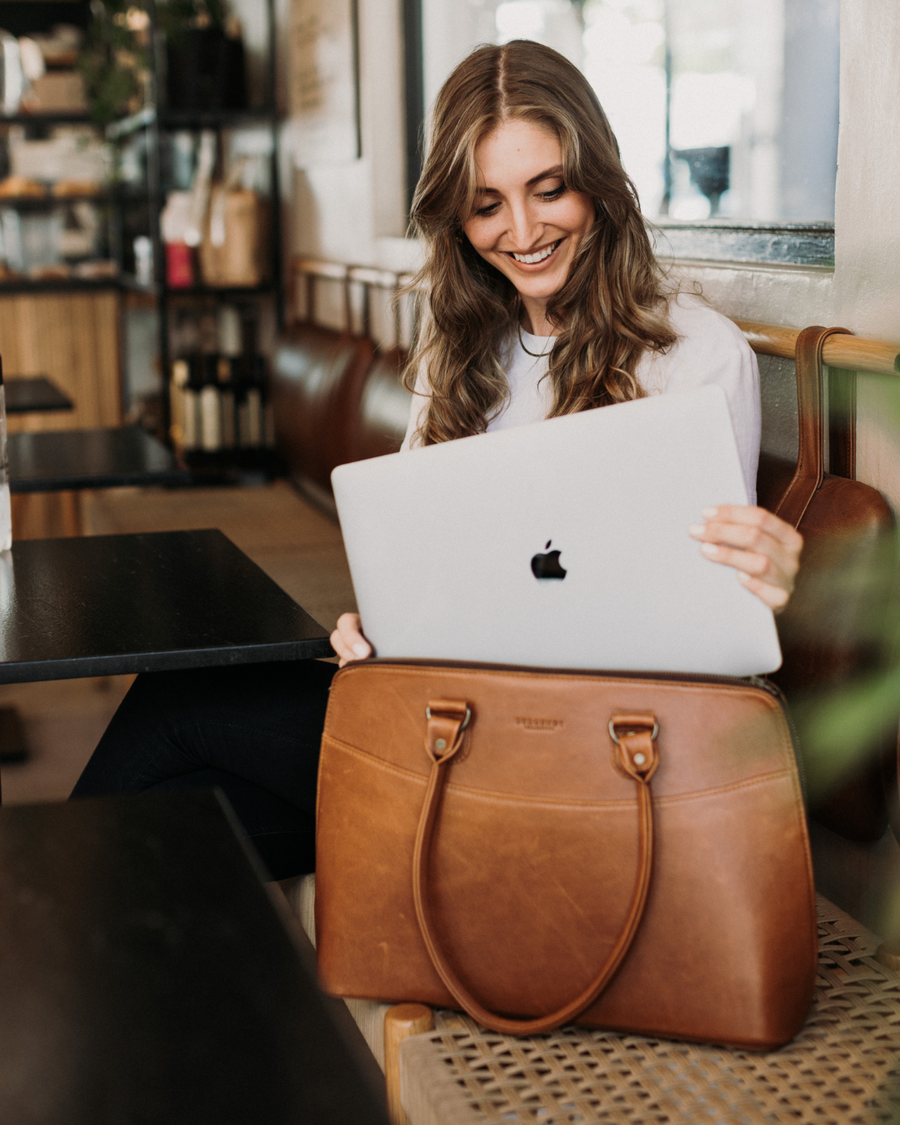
[462,119,594,335]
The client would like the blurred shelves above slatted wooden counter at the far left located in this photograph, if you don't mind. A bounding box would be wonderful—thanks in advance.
[0,0,122,430]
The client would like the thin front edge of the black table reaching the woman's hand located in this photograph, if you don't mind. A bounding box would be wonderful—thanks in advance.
[0,632,335,684]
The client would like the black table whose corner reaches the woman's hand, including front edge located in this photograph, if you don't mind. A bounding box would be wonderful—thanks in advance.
[0,530,333,684]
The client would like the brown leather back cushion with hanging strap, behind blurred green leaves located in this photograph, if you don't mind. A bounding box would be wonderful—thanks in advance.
[757,326,896,840]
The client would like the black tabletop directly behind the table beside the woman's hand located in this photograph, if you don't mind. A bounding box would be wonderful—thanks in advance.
[9,426,190,493]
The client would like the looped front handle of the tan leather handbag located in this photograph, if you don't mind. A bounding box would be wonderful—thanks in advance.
[413,700,659,1035]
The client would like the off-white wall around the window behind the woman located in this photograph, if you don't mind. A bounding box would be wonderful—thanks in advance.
[281,0,900,511]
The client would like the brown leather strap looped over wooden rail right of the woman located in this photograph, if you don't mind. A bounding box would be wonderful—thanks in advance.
[775,325,849,528]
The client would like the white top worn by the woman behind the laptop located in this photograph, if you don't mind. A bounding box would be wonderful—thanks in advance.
[403,294,761,503]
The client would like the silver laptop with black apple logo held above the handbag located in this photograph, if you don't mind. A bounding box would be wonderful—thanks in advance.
[332,387,781,676]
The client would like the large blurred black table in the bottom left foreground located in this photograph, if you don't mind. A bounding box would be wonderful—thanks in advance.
[0,791,387,1125]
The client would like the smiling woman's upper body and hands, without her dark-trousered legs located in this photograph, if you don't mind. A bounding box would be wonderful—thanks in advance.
[332,41,802,663]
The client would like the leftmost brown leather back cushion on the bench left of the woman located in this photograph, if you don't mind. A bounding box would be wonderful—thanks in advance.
[271,324,375,493]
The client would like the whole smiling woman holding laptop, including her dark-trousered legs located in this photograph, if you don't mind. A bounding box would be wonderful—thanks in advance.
[73,41,802,879]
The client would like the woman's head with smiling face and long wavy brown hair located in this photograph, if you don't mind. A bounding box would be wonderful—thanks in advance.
[412,39,677,444]
